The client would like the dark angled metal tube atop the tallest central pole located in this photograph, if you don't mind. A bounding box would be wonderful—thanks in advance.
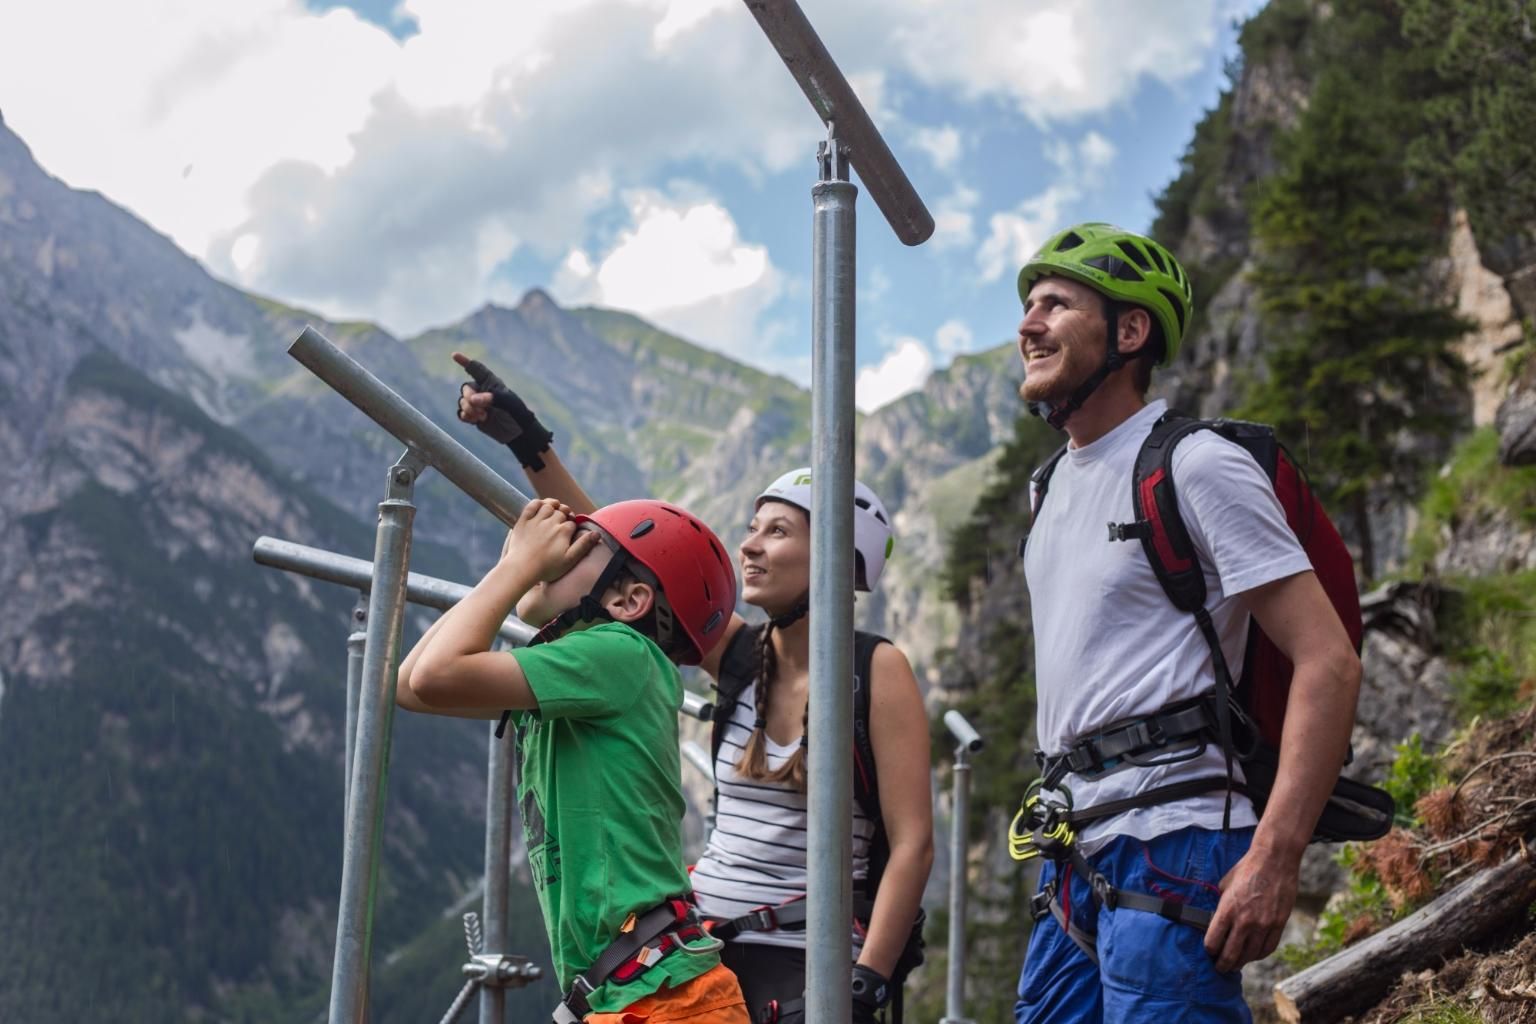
[734,0,934,246]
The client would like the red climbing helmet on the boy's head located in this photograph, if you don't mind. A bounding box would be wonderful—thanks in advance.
[576,499,736,665]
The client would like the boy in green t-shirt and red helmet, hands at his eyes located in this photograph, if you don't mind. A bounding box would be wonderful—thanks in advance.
[396,499,748,1024]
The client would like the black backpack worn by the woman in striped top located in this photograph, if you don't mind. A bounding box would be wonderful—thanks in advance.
[710,625,926,990]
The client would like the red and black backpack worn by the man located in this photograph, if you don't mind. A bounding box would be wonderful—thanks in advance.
[1031,413,1396,841]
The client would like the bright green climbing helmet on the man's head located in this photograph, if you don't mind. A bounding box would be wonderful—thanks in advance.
[1018,221,1195,365]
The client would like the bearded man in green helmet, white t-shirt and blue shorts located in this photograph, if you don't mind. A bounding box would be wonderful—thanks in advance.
[1015,224,1361,1024]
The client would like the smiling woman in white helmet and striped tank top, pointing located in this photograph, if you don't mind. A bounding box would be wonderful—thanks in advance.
[453,353,932,1021]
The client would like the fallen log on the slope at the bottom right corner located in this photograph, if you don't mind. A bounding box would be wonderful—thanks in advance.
[1275,851,1536,1024]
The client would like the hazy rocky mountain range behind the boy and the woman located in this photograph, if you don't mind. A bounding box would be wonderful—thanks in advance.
[0,104,1018,1024]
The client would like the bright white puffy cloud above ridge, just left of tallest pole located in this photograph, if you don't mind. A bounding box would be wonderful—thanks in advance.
[554,190,780,364]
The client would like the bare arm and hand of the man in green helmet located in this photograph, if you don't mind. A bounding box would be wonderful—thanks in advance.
[1206,571,1361,970]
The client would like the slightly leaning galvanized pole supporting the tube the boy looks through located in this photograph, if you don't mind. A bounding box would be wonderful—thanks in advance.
[330,450,425,1024]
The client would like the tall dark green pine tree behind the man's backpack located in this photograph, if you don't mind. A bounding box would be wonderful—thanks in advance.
[1243,5,1467,579]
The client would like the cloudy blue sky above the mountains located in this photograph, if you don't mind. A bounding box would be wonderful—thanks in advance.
[0,0,1261,411]
